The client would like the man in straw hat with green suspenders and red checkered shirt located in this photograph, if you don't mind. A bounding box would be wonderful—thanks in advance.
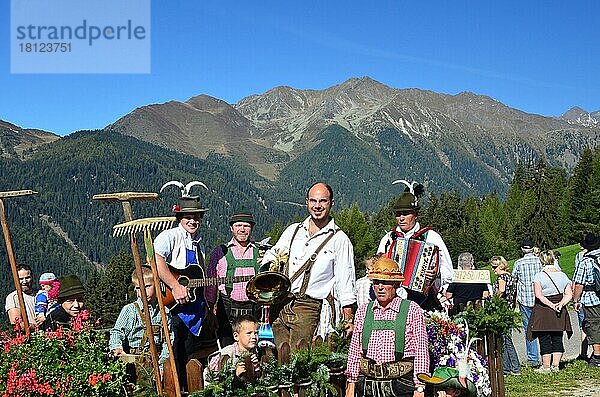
[346,257,429,397]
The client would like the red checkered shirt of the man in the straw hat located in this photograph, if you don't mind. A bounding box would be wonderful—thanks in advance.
[346,297,429,384]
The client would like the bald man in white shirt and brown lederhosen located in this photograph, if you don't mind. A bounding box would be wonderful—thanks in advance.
[262,182,356,349]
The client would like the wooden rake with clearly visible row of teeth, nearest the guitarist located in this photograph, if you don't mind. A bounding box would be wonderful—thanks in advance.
[113,216,181,397]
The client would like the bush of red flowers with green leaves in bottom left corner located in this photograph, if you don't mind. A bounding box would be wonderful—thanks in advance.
[0,311,126,397]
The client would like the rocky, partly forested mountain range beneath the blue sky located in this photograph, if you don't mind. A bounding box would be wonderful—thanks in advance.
[0,77,600,316]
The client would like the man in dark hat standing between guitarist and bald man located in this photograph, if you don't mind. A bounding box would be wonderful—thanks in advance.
[206,208,259,346]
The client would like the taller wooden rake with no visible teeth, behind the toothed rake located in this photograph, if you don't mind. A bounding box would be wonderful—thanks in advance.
[92,192,170,397]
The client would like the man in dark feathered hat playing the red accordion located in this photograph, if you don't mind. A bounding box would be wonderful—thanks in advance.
[377,192,454,310]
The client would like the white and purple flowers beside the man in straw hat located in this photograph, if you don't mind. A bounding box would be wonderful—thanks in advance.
[425,311,492,396]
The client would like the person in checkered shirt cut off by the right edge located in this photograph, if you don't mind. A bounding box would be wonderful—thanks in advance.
[573,233,600,367]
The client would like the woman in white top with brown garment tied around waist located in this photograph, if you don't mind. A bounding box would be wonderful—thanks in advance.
[527,250,573,372]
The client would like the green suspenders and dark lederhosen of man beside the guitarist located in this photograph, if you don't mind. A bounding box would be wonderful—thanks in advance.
[221,246,259,324]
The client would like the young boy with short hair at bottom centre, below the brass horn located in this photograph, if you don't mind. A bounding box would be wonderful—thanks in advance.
[208,315,258,378]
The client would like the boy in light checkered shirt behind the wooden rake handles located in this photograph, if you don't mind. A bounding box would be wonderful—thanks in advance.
[108,266,173,364]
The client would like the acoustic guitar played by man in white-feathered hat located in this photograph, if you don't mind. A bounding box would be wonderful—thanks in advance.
[161,265,254,310]
